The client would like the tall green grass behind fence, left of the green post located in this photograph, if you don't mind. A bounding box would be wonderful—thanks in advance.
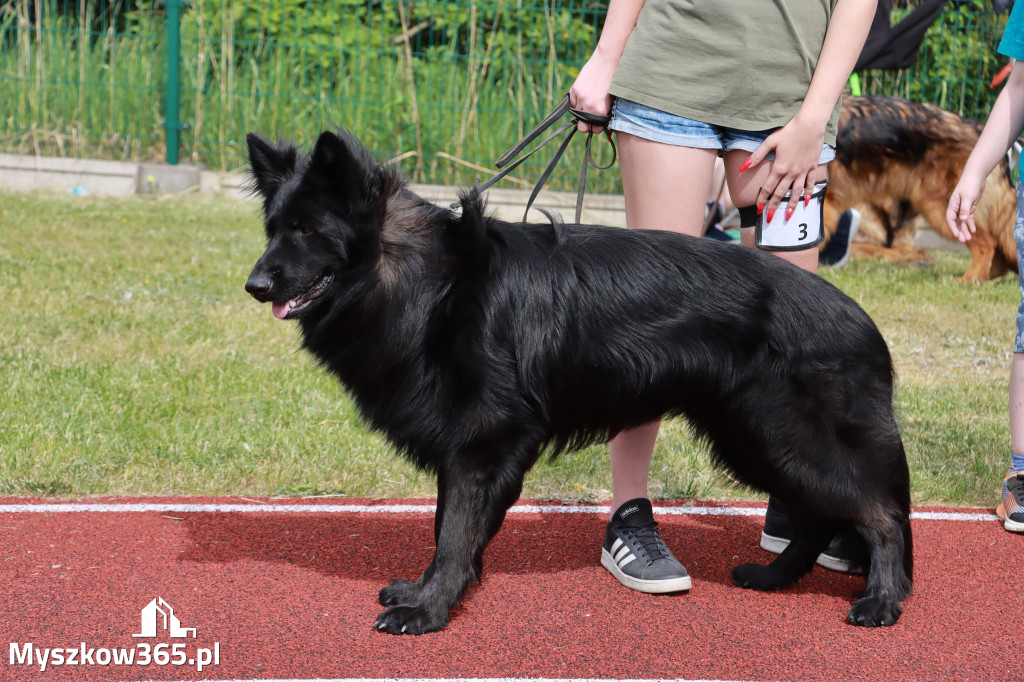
[0,0,164,159]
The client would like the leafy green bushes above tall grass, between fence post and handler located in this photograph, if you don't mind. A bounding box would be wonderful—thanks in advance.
[184,0,596,86]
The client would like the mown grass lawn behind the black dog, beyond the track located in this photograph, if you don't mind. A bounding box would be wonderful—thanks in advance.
[0,188,1018,506]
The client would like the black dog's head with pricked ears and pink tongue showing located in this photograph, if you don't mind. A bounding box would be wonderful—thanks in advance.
[246,132,394,319]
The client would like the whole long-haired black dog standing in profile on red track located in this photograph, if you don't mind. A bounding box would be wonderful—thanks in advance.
[246,132,911,633]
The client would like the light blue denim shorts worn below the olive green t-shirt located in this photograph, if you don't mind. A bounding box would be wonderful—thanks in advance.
[608,97,836,164]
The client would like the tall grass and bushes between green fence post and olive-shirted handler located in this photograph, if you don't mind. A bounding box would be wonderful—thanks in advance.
[160,0,598,183]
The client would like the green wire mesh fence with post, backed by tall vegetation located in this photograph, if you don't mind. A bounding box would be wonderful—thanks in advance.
[0,0,1006,191]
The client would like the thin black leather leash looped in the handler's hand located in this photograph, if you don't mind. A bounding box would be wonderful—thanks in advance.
[452,94,616,223]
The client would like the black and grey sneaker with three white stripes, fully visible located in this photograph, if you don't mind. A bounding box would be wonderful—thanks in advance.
[601,498,690,594]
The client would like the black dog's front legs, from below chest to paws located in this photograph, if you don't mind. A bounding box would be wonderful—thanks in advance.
[374,449,537,635]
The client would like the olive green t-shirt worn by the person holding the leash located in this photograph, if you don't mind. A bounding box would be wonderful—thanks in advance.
[610,0,839,146]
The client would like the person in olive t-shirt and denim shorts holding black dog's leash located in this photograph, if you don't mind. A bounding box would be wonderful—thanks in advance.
[569,0,876,592]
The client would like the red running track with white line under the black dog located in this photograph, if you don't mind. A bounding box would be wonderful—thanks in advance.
[0,499,1024,682]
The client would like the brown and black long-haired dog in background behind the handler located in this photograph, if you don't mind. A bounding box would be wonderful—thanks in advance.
[824,96,1017,282]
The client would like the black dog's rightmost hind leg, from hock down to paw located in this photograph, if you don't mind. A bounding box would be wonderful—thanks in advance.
[847,501,912,627]
